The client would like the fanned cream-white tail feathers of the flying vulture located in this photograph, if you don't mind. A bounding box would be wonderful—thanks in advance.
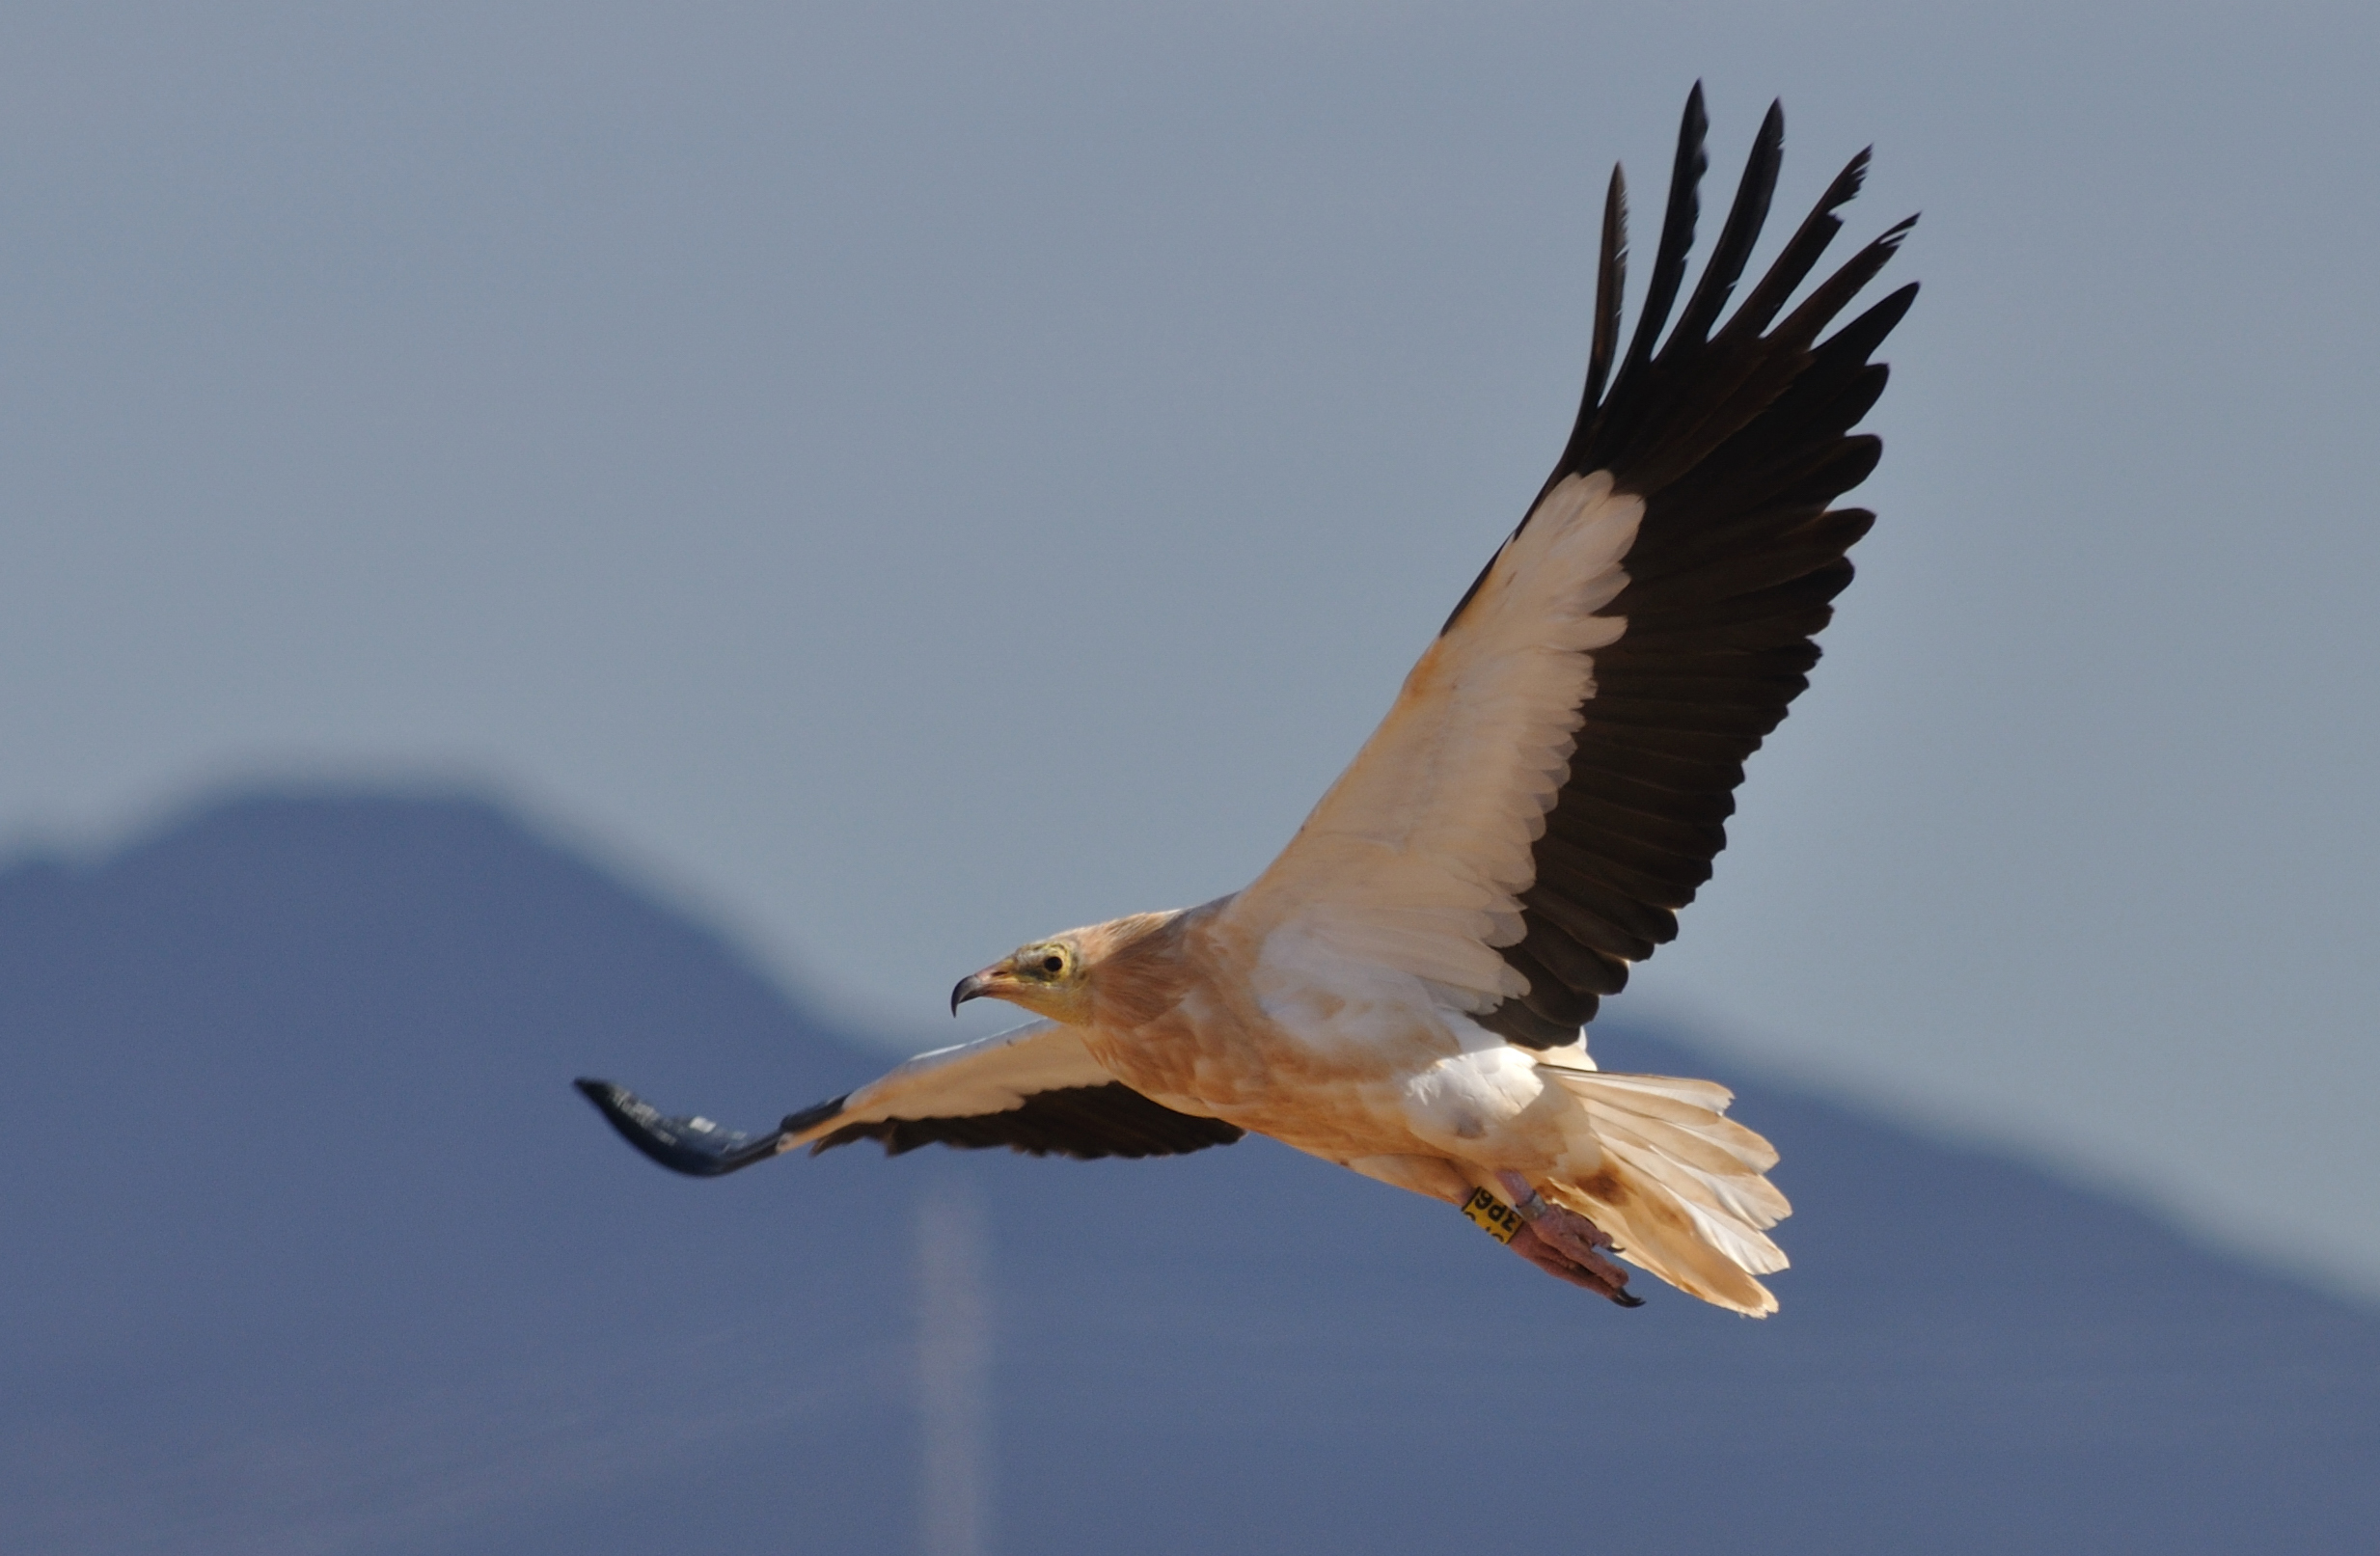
[1538,1063,1792,1316]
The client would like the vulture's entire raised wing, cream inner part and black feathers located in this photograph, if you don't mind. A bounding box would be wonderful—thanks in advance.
[1226,86,1916,1047]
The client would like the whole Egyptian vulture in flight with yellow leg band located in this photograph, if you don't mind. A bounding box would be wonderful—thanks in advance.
[578,86,1918,1316]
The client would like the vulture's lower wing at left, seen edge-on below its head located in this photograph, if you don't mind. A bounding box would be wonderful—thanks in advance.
[578,1021,1243,1178]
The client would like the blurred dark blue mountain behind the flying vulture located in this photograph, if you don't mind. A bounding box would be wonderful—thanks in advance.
[0,795,2380,1556]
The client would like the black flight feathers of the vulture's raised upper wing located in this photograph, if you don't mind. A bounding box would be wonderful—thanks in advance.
[1447,83,1918,1050]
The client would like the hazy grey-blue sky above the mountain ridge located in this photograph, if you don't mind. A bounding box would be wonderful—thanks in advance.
[0,0,2380,1295]
